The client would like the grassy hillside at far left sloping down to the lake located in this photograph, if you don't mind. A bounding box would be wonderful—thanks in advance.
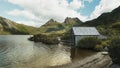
[0,17,36,34]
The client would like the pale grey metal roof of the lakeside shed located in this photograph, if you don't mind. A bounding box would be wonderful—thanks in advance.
[73,27,100,35]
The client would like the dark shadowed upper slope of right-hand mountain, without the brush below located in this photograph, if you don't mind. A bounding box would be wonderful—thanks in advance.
[82,6,120,26]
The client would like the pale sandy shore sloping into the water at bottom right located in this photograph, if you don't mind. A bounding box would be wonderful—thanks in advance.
[47,52,111,68]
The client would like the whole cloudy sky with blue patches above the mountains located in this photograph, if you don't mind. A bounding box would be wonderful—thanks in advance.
[0,0,120,27]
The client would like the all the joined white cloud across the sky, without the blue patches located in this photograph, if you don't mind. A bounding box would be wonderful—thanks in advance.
[7,0,120,26]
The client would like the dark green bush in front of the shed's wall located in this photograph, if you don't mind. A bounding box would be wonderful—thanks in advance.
[78,37,109,51]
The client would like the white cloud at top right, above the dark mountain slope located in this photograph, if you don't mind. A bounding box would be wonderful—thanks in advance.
[90,0,120,19]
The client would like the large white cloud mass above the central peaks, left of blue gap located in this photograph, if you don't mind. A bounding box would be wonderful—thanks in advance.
[8,0,92,24]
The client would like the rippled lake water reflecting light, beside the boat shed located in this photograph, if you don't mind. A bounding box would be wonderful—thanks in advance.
[0,35,96,68]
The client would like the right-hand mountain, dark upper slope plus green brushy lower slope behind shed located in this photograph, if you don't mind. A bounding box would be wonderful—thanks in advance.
[80,6,120,37]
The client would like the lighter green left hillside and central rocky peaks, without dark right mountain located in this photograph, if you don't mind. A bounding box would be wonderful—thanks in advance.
[0,17,82,34]
